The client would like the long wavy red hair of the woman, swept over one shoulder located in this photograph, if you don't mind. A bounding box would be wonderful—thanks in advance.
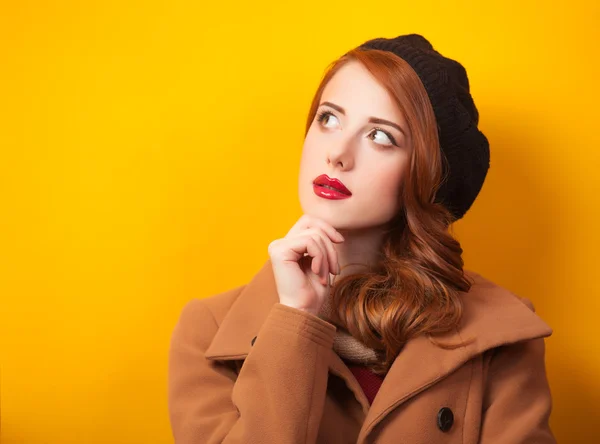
[305,49,471,374]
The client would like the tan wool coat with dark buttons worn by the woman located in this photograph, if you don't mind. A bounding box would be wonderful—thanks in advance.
[168,261,555,444]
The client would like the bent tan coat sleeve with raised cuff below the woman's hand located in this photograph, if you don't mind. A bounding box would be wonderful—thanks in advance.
[168,299,336,444]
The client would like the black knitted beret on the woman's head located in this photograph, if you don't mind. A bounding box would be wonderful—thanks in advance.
[359,34,490,220]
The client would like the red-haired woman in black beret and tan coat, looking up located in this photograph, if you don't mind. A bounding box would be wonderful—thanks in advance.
[169,34,555,444]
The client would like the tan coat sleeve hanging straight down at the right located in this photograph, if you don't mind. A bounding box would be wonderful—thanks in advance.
[480,338,556,444]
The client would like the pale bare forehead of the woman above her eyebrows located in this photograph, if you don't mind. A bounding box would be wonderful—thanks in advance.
[321,60,404,123]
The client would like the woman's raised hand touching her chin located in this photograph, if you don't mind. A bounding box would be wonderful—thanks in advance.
[269,214,344,315]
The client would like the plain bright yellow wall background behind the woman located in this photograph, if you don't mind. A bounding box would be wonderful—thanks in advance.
[0,0,600,444]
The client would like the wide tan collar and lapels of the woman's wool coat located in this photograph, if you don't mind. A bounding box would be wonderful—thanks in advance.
[205,260,552,442]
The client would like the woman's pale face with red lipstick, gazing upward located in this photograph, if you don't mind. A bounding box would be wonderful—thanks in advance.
[299,61,411,230]
